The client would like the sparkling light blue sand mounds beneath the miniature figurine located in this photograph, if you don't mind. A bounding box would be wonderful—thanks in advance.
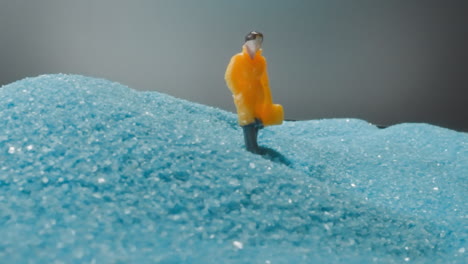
[0,75,468,263]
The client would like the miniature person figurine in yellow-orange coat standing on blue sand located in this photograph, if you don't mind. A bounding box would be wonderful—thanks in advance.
[224,31,284,154]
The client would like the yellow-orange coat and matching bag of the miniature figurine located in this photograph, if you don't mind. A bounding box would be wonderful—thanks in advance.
[224,47,284,126]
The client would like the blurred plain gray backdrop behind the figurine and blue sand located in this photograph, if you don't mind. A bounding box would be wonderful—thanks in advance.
[0,0,468,131]
